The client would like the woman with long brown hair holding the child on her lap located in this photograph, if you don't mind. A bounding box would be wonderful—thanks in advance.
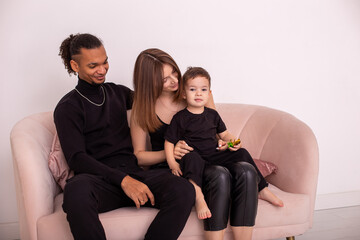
[131,49,258,240]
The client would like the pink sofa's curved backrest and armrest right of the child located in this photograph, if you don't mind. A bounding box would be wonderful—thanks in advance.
[217,104,319,199]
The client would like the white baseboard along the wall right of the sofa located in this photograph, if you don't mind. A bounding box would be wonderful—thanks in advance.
[315,191,360,210]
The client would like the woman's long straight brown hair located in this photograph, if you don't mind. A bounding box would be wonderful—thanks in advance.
[131,48,182,132]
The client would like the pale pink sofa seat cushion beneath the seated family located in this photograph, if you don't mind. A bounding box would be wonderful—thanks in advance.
[37,184,311,240]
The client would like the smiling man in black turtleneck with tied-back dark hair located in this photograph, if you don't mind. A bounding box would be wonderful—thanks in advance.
[54,34,195,240]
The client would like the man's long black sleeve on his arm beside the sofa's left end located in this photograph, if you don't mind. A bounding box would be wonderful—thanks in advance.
[54,103,127,186]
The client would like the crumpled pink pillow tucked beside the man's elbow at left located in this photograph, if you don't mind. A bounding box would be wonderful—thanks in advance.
[48,133,74,190]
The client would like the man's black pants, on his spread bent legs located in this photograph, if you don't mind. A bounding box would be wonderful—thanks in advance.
[63,169,195,240]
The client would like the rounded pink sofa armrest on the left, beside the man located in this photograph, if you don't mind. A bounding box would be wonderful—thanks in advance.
[10,112,60,240]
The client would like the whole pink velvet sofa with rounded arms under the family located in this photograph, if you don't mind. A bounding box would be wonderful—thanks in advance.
[11,104,319,240]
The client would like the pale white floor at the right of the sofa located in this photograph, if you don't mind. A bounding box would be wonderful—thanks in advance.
[279,206,360,240]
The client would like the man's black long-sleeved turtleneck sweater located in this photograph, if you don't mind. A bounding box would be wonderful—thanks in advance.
[54,79,141,185]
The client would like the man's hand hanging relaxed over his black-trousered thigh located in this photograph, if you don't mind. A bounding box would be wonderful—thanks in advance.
[121,176,155,208]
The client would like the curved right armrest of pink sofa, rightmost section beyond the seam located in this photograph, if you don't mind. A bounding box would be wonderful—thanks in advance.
[260,113,319,197]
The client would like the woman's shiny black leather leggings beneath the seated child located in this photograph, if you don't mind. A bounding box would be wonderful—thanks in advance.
[182,149,267,231]
